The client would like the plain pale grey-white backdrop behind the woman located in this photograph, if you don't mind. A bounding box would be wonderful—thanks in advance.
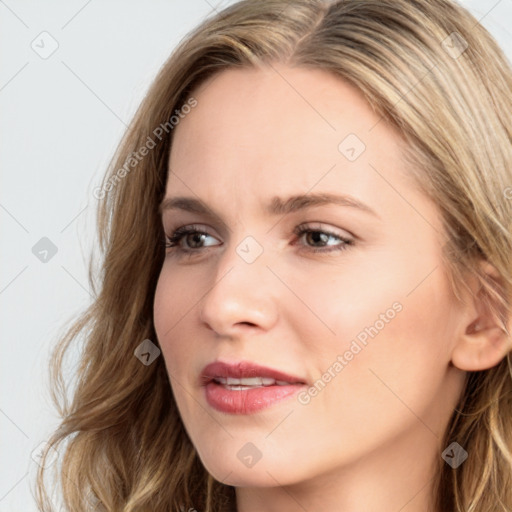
[0,0,512,512]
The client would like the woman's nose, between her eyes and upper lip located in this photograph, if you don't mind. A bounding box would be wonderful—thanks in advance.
[200,238,279,338]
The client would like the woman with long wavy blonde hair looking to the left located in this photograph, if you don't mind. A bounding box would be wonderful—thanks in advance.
[38,0,512,512]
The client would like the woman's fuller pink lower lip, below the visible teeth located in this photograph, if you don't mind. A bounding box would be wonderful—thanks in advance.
[205,381,305,414]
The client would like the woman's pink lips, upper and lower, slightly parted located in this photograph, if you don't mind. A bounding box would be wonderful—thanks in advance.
[200,361,307,414]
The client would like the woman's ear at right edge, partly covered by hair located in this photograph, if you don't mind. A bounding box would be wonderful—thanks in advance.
[451,261,512,371]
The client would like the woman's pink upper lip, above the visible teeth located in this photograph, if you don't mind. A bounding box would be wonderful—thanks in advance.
[200,361,306,386]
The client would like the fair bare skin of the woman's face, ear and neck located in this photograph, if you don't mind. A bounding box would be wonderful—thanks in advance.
[154,64,505,512]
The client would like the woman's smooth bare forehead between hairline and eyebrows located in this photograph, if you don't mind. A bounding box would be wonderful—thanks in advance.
[167,65,412,216]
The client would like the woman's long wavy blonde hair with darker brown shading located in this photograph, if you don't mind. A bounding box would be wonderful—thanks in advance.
[35,0,512,512]
